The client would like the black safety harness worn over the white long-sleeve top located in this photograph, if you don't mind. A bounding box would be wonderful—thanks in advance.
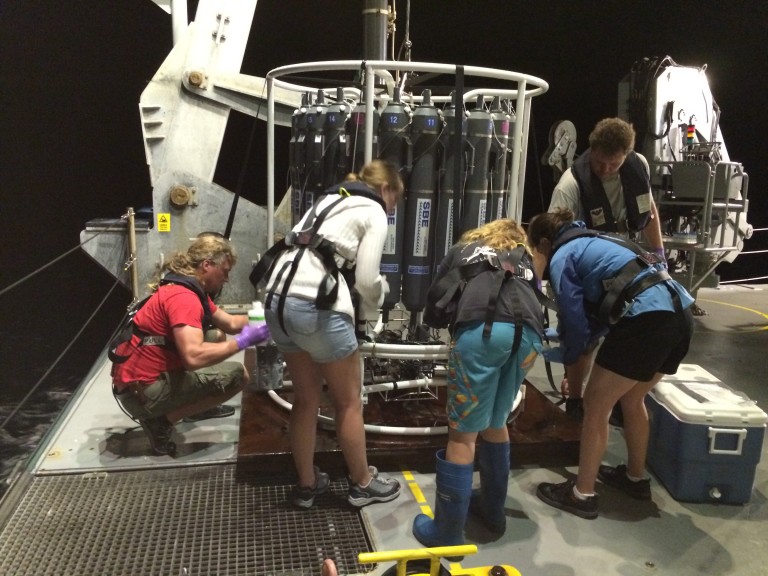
[248,181,386,330]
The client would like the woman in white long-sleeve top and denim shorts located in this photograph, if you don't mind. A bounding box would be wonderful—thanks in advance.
[265,160,403,508]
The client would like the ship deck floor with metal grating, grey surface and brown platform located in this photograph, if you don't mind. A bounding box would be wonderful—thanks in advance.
[0,286,768,576]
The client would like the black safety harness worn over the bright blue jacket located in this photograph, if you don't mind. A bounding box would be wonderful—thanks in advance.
[550,228,680,326]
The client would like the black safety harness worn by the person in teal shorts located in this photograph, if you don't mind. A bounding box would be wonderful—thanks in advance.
[424,245,556,354]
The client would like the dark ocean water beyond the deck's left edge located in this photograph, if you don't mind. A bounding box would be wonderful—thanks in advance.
[0,252,130,495]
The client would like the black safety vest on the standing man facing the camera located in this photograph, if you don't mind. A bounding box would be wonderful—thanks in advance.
[571,150,651,232]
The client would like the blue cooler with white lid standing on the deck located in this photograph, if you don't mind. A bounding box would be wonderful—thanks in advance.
[645,364,768,504]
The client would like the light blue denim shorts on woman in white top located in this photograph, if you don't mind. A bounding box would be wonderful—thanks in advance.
[264,296,357,364]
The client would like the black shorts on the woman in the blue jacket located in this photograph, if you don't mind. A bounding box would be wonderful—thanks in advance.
[595,308,693,382]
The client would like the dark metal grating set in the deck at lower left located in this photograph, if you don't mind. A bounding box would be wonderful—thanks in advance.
[0,465,373,576]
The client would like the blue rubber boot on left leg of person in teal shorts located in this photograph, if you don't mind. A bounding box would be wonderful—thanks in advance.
[413,450,474,548]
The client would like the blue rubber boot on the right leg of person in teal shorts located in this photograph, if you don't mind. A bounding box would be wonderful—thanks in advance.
[469,442,509,534]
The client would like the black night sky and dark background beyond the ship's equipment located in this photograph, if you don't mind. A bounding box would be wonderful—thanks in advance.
[0,0,768,420]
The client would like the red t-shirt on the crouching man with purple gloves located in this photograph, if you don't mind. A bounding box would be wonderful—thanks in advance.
[112,284,218,387]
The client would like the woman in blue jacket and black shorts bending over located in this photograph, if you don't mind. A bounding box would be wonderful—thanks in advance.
[528,209,693,519]
